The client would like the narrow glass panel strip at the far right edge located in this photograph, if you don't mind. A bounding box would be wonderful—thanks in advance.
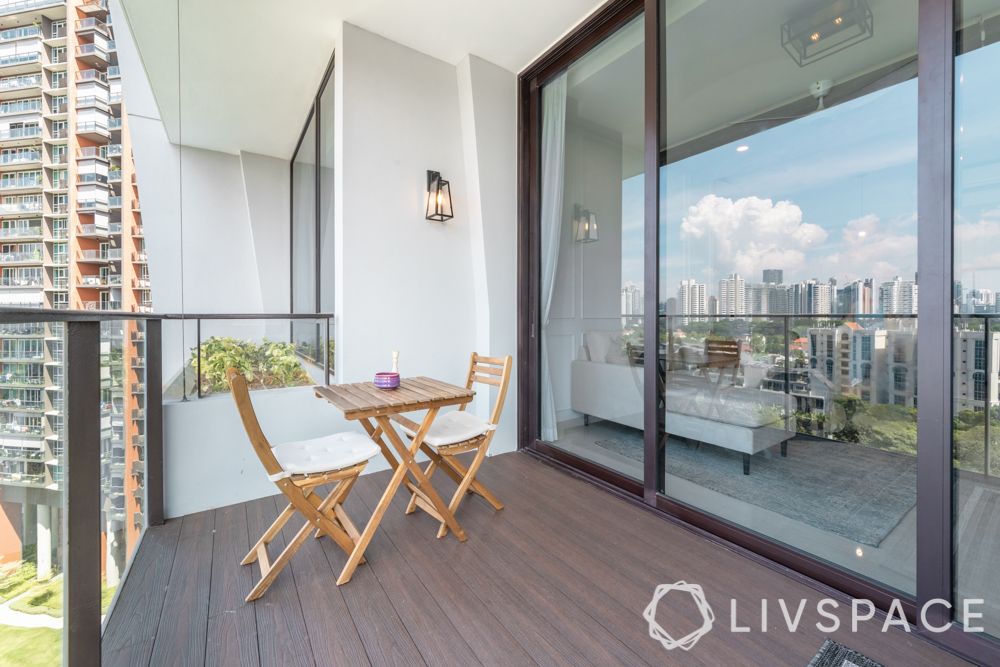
[952,0,1000,637]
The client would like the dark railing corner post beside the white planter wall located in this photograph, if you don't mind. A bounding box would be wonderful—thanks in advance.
[146,320,163,526]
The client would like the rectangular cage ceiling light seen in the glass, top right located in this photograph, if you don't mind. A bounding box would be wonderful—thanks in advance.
[781,0,875,67]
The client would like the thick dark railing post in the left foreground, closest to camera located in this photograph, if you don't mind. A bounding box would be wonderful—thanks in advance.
[63,321,101,665]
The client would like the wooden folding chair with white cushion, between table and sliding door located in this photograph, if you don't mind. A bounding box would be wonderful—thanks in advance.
[399,352,514,537]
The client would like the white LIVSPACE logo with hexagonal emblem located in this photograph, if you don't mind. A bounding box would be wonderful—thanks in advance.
[642,581,984,651]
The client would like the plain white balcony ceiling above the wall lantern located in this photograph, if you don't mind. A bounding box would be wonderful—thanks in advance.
[122,0,602,158]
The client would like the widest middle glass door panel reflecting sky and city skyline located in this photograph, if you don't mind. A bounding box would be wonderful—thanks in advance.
[660,0,918,594]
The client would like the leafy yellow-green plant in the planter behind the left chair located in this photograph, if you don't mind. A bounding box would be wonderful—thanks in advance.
[191,336,311,394]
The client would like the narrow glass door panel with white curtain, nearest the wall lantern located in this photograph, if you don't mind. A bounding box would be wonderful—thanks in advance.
[539,11,644,480]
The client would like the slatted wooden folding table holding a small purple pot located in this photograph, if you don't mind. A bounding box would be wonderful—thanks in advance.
[315,377,476,585]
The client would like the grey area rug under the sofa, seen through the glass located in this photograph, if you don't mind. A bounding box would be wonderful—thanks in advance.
[595,429,917,546]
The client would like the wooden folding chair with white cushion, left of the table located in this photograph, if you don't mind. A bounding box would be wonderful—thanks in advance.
[226,368,379,602]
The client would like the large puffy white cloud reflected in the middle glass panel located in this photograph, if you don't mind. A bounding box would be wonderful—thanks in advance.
[681,194,827,281]
